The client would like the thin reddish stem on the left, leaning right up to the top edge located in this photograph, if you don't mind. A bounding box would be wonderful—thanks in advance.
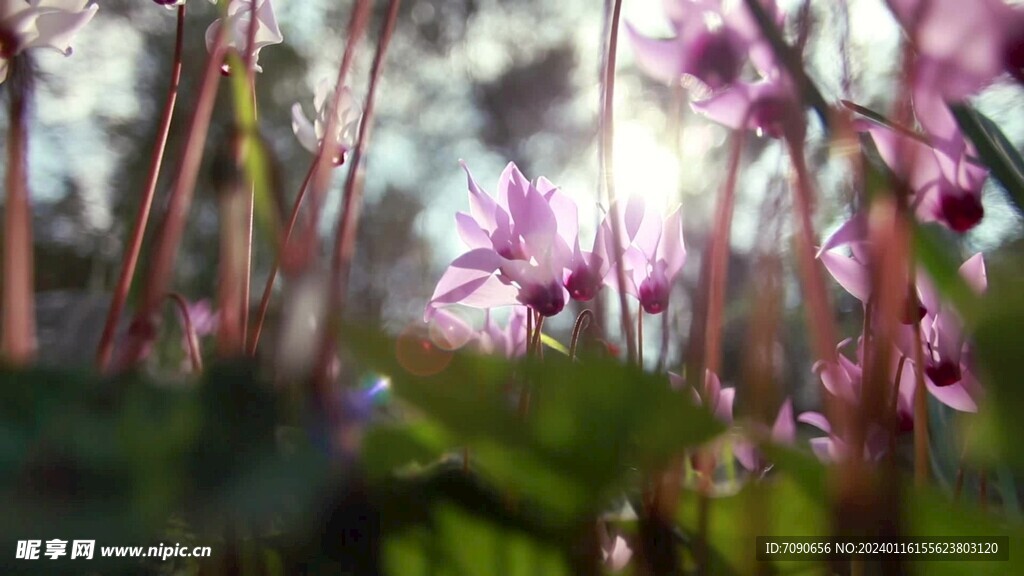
[96,4,185,370]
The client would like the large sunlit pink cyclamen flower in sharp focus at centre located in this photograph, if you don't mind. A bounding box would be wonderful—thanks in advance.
[424,162,574,320]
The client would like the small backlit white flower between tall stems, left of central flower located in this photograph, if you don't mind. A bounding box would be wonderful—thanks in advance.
[292,78,361,166]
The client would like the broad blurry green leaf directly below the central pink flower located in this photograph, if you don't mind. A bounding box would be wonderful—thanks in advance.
[347,325,723,524]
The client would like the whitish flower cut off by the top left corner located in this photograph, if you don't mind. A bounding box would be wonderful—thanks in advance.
[0,0,99,82]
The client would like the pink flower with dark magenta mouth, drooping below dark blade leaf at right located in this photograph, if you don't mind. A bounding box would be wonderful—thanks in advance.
[862,122,988,233]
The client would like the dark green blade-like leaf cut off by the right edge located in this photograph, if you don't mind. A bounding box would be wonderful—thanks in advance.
[950,104,1024,213]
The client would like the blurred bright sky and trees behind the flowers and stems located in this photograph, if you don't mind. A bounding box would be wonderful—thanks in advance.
[6,0,1024,405]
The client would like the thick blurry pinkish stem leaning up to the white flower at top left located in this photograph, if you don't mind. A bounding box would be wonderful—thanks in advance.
[117,27,227,366]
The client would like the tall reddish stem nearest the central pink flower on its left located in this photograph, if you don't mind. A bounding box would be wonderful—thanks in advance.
[313,0,401,384]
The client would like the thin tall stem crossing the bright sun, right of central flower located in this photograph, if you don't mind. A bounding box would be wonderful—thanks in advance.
[601,0,637,364]
